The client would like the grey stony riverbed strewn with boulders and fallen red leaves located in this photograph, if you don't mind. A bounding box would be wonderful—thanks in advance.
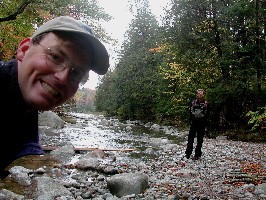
[0,111,266,200]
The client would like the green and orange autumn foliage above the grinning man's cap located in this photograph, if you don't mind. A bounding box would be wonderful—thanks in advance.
[0,0,112,60]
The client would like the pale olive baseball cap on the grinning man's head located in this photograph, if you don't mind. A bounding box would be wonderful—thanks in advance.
[32,16,110,75]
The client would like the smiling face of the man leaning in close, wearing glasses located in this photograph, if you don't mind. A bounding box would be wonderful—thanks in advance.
[17,33,90,110]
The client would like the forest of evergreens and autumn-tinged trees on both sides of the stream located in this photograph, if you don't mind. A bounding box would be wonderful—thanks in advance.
[0,0,266,140]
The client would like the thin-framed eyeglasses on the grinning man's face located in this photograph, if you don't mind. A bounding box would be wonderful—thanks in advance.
[38,43,88,86]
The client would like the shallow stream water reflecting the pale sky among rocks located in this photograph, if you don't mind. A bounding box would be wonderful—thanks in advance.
[39,113,184,161]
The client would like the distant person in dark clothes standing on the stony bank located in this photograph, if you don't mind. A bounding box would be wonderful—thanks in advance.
[185,89,210,160]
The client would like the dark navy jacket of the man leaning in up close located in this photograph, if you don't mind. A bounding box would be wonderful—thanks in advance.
[0,59,43,173]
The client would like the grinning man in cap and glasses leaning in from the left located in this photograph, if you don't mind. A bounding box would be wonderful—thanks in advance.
[0,16,109,178]
